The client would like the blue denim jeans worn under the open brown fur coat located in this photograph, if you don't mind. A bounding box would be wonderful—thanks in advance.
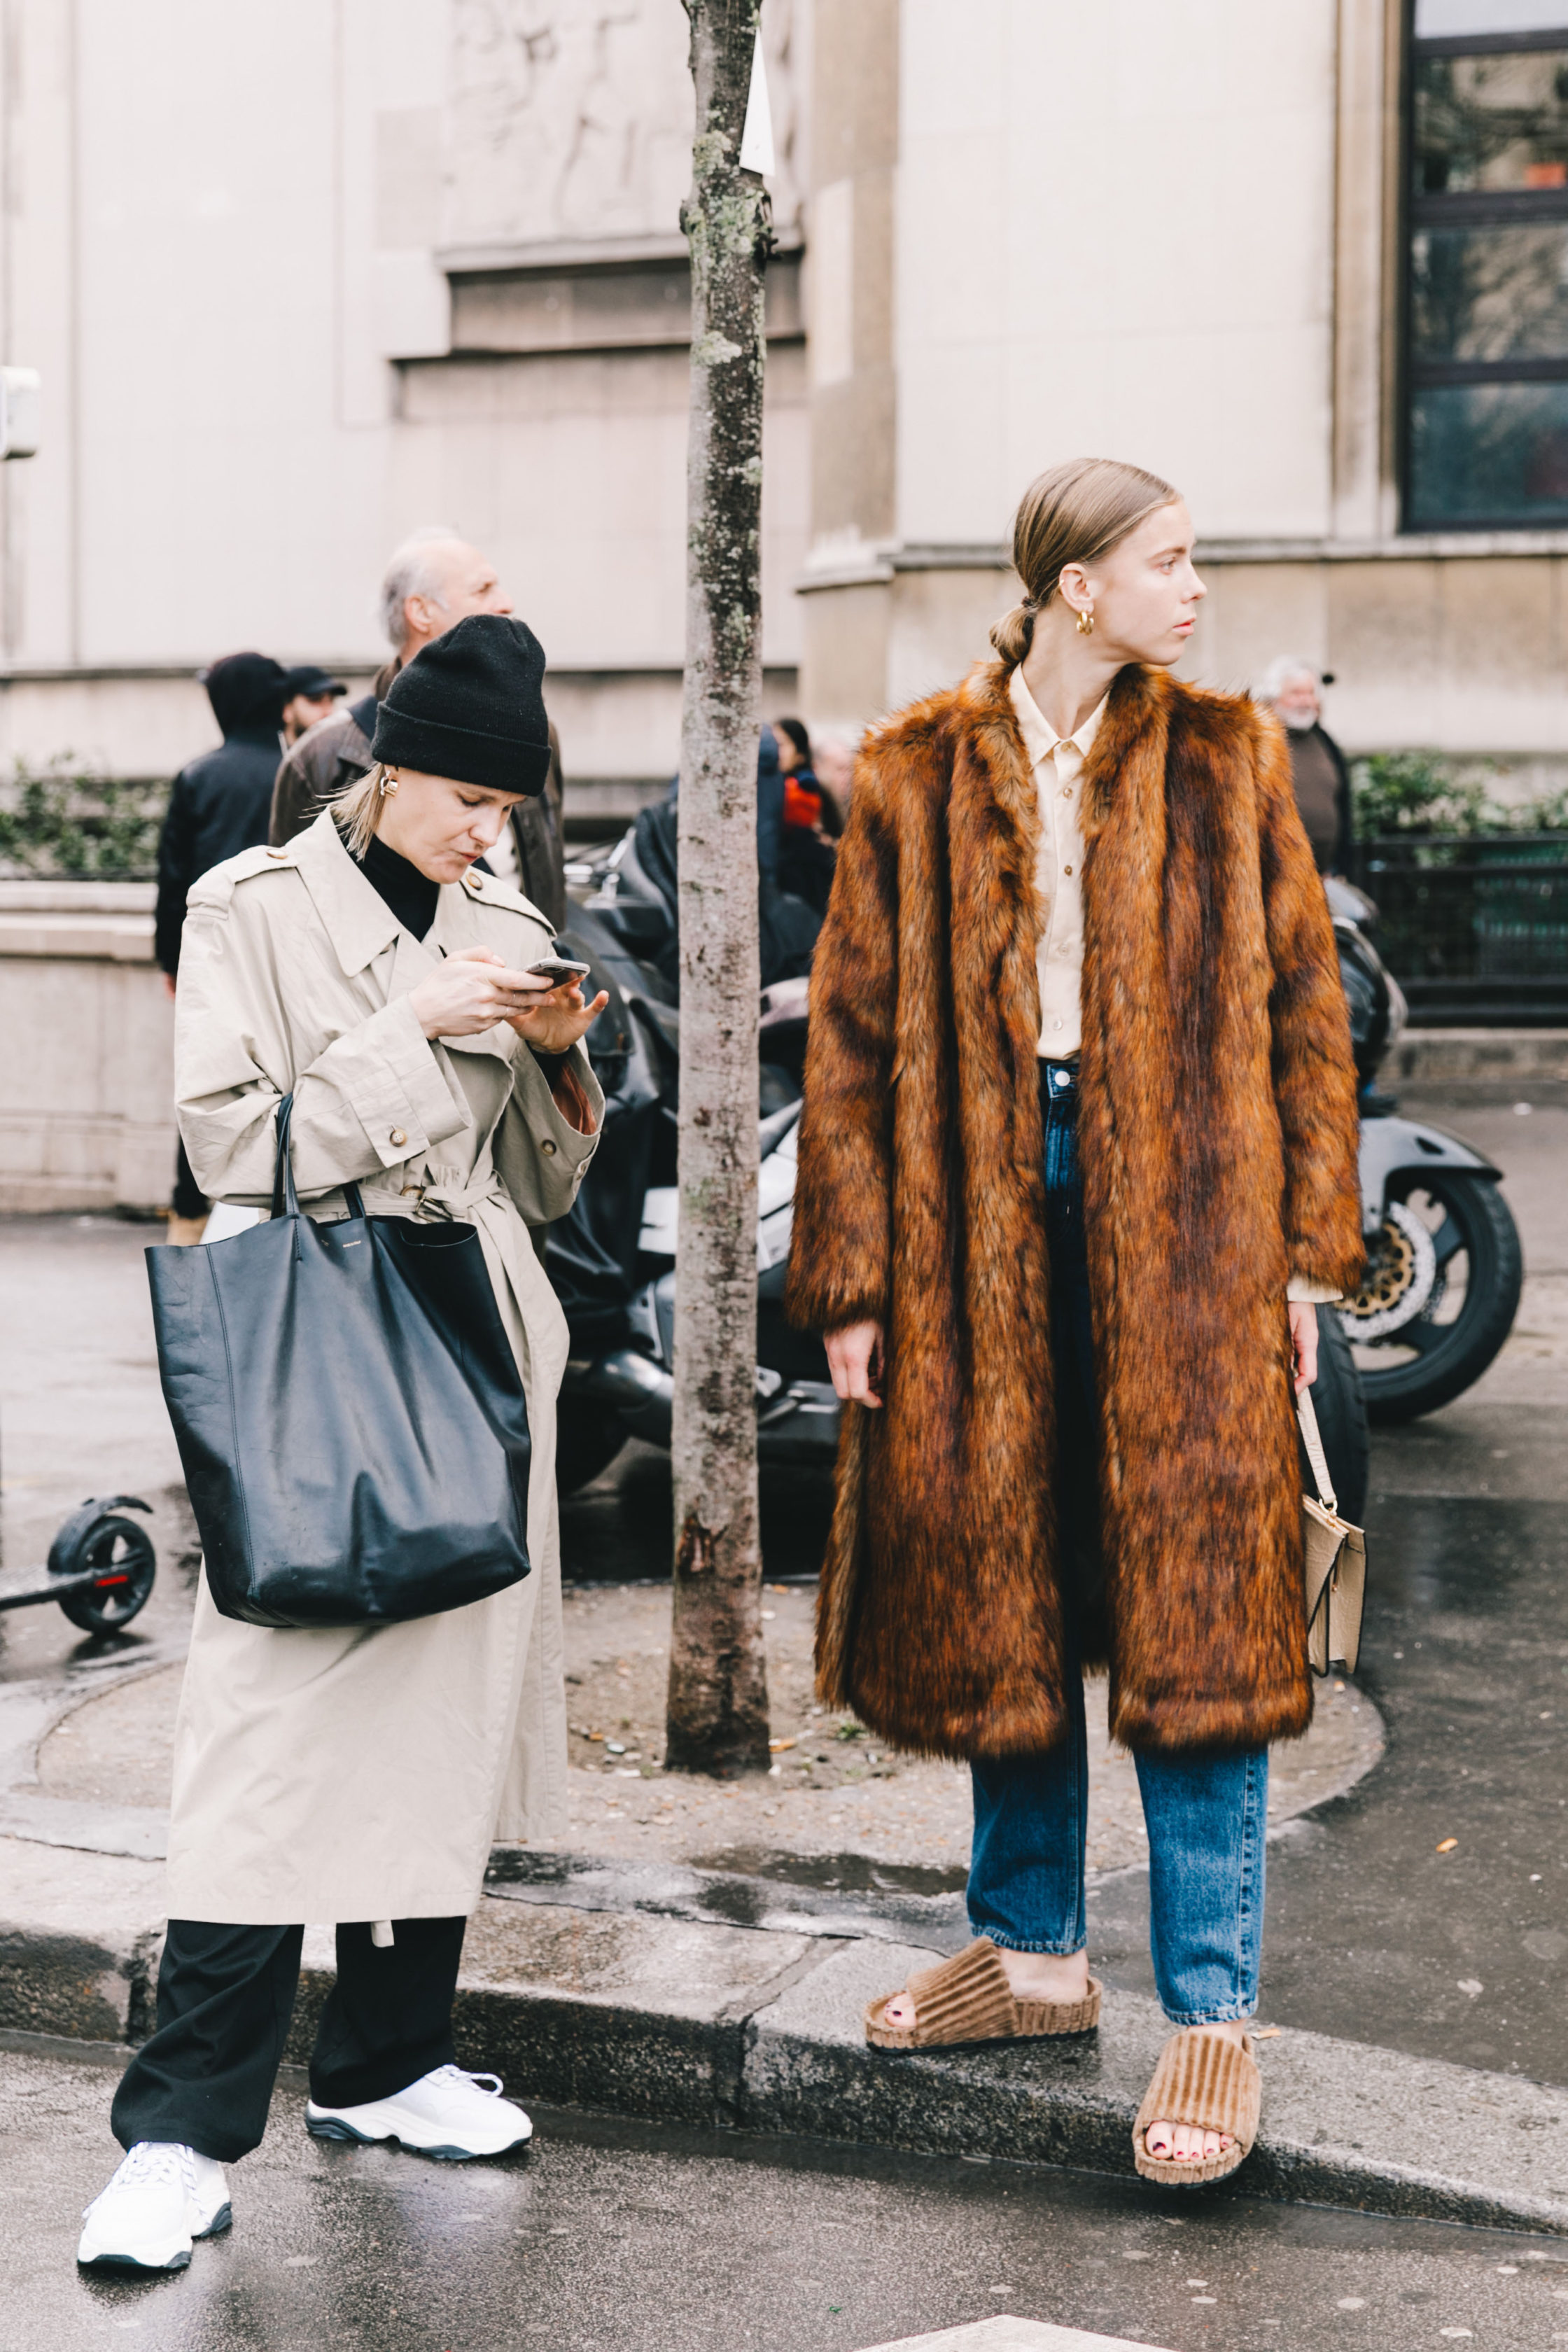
[969,1063,1269,2025]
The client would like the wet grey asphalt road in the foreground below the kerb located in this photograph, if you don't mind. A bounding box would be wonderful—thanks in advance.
[0,2044,1568,2352]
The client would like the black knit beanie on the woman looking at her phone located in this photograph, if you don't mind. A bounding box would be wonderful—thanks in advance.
[372,612,550,795]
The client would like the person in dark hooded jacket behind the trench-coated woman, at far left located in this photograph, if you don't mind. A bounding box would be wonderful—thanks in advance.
[153,654,296,1247]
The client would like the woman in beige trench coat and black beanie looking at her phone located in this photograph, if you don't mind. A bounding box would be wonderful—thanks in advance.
[80,614,604,2269]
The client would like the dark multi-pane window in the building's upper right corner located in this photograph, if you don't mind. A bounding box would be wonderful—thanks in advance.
[1404,0,1568,531]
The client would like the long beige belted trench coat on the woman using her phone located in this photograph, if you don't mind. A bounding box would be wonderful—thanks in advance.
[169,814,604,1926]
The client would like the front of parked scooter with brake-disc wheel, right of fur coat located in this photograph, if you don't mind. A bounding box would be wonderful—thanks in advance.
[1319,880,1523,1423]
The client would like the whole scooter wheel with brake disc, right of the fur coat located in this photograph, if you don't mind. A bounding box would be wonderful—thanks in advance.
[1338,1169,1523,1425]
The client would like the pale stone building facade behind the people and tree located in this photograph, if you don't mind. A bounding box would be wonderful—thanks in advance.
[0,0,1568,823]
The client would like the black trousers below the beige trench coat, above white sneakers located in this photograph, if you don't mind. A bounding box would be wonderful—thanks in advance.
[111,1919,468,2164]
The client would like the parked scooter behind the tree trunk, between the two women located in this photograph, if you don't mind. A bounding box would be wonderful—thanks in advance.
[545,821,1368,1520]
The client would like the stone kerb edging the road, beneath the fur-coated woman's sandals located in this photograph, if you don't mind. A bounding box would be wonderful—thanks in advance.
[0,1844,1568,2234]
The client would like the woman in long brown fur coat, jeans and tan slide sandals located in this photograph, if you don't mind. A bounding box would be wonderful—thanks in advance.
[790,458,1361,2183]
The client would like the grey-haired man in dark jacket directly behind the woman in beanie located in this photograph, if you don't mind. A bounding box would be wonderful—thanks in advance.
[268,524,566,929]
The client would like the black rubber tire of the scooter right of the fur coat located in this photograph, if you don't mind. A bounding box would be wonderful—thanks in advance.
[1340,1169,1523,1428]
